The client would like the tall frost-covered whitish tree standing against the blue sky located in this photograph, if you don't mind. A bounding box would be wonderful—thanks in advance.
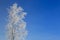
[7,3,27,40]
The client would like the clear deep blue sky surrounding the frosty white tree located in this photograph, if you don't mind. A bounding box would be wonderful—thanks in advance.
[0,0,60,40]
